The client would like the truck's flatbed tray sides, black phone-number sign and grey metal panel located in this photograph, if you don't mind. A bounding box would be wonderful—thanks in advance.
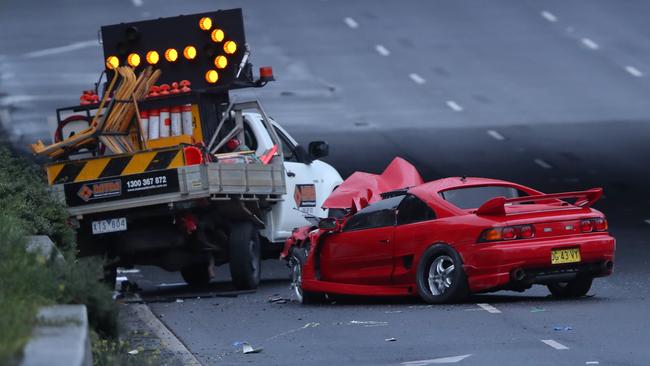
[52,162,286,216]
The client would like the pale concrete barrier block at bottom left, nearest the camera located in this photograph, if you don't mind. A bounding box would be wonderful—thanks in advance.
[21,305,93,366]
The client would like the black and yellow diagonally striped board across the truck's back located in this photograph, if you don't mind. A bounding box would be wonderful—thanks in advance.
[46,147,185,185]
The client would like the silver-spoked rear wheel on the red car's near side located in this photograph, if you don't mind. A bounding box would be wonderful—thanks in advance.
[416,244,468,304]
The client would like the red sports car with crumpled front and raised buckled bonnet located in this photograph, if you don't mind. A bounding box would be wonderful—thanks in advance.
[281,158,616,303]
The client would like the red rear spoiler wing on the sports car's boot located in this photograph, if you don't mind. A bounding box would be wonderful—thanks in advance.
[476,188,603,216]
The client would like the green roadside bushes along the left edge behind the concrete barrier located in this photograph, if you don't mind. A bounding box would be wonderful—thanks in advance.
[0,144,153,365]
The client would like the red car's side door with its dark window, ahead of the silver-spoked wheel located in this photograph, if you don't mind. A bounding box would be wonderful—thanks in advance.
[320,197,403,285]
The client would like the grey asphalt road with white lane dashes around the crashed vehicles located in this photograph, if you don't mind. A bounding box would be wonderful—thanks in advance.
[0,0,650,365]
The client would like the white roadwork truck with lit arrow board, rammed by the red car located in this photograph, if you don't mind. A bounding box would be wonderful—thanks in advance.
[39,9,342,289]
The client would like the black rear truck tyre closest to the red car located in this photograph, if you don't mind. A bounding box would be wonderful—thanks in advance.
[229,222,262,290]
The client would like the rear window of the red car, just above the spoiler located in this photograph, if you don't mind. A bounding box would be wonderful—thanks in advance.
[440,185,526,210]
